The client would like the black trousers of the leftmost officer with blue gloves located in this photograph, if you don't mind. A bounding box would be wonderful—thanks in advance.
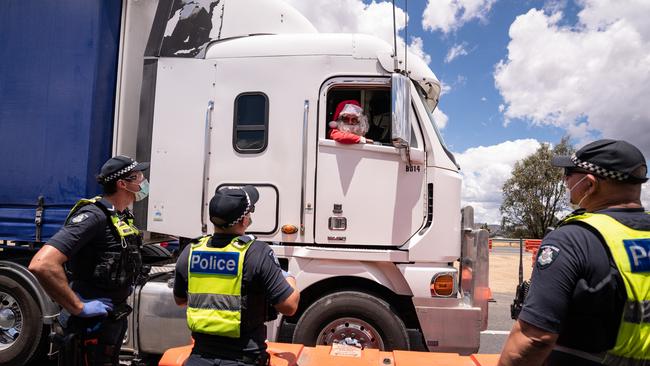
[59,317,127,366]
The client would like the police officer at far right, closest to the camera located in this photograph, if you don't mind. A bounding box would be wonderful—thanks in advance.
[499,140,650,366]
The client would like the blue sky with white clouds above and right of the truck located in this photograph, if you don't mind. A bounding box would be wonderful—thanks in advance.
[286,0,650,223]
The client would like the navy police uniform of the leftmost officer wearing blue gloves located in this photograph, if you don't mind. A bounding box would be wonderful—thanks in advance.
[48,200,141,364]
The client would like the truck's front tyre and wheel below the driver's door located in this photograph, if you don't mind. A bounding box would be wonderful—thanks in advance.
[293,291,409,351]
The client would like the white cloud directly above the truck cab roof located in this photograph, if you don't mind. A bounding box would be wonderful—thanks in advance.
[285,0,431,64]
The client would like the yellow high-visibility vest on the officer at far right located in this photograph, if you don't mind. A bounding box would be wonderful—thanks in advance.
[562,213,650,365]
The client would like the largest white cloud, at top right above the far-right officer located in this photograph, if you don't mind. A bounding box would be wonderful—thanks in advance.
[494,0,650,156]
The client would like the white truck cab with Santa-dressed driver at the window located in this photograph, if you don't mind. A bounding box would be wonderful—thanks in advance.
[117,0,488,354]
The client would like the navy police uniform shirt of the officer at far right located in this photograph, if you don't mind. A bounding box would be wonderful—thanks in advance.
[519,208,650,366]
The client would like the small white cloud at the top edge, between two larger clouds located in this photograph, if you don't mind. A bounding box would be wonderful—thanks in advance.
[422,0,496,33]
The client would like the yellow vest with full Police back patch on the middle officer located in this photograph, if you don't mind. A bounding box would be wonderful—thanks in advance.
[187,236,255,338]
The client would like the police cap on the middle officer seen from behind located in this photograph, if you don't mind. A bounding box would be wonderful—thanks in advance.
[210,185,260,227]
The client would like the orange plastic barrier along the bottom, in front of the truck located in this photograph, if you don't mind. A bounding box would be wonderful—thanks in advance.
[158,342,499,366]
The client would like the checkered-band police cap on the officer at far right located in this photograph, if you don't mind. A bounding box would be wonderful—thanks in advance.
[551,139,648,183]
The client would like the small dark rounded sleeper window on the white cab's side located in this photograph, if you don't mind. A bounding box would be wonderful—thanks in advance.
[232,92,269,154]
